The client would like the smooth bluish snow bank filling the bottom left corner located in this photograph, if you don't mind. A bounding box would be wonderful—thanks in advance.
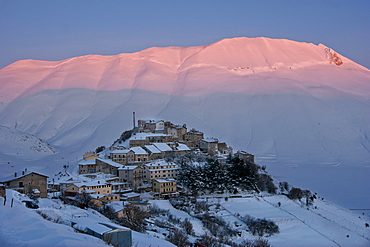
[0,190,107,247]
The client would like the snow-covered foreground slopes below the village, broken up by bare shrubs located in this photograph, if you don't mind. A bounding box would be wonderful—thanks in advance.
[0,190,370,247]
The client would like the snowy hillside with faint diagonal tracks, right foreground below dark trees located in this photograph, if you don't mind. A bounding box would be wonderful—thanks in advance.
[152,195,370,247]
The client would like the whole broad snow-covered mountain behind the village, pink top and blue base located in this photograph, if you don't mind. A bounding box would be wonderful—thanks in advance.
[0,38,370,211]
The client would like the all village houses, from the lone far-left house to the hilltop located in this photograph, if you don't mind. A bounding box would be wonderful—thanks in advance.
[0,120,254,210]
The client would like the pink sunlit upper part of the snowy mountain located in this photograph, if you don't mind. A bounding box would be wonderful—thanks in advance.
[0,38,369,102]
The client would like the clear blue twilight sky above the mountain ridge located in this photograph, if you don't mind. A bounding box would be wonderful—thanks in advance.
[0,0,370,68]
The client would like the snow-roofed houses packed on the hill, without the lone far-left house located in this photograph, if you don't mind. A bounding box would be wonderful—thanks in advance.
[69,120,254,202]
